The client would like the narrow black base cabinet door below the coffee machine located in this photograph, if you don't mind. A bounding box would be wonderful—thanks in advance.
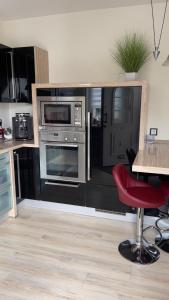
[14,148,40,201]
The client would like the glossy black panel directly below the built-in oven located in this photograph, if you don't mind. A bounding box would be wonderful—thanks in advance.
[38,180,85,206]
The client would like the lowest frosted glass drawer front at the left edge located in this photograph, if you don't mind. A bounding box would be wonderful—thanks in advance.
[0,185,12,216]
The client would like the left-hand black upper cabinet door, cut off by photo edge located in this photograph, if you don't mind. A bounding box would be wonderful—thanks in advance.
[0,45,14,102]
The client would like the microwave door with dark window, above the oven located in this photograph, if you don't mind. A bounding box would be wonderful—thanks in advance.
[41,101,74,127]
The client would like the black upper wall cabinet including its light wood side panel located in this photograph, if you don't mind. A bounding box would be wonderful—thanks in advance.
[0,47,49,103]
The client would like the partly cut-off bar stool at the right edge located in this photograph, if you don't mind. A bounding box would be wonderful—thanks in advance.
[155,181,169,253]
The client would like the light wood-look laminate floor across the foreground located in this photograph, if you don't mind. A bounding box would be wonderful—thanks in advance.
[0,208,169,300]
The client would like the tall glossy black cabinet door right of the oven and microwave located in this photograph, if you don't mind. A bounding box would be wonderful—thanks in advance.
[86,87,141,213]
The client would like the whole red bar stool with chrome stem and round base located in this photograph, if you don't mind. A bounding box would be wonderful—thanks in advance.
[112,164,165,264]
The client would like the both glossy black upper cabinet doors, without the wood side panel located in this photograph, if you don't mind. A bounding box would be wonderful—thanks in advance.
[0,45,35,103]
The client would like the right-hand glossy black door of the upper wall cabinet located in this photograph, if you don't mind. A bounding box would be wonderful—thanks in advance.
[13,47,35,103]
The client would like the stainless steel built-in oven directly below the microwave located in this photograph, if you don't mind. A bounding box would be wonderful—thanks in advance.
[40,129,86,183]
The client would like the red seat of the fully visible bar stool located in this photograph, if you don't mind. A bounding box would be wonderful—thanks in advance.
[113,164,164,208]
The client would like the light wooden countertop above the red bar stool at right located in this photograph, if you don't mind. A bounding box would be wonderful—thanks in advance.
[132,141,169,175]
